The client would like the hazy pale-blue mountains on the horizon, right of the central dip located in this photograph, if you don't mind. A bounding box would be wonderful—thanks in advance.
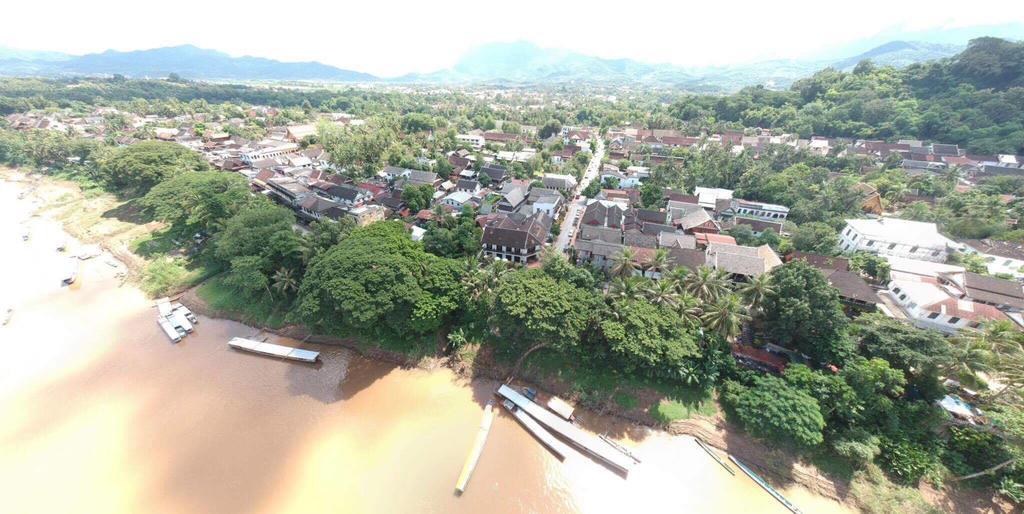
[392,41,964,91]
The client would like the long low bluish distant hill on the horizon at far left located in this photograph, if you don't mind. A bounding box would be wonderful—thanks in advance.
[0,45,377,82]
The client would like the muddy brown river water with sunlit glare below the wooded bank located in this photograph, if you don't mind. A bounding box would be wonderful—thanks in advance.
[0,178,850,514]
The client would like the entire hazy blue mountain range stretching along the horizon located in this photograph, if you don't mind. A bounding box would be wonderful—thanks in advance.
[0,41,978,91]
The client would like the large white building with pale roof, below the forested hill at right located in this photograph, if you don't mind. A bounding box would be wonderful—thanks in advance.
[839,218,958,262]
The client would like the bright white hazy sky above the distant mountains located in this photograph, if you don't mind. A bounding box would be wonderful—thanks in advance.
[0,0,1024,76]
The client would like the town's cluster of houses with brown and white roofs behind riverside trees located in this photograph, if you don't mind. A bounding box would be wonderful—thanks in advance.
[7,108,1024,369]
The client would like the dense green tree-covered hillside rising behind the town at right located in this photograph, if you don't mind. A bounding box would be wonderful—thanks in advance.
[669,38,1024,154]
